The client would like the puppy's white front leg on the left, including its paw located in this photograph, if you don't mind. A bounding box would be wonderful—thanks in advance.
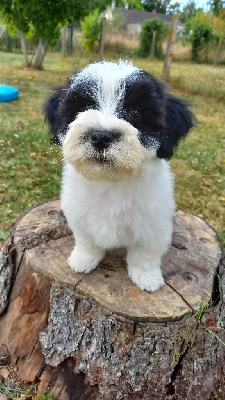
[67,231,105,273]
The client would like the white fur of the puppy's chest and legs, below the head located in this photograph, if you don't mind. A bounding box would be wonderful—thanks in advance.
[61,158,175,292]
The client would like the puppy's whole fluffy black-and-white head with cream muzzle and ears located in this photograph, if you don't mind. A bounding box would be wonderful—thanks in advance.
[45,61,194,181]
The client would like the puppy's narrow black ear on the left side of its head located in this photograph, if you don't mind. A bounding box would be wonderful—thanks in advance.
[44,86,66,144]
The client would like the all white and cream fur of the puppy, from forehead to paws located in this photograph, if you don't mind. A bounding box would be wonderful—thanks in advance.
[61,62,175,292]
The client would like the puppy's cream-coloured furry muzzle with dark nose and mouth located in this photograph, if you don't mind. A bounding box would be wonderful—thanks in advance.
[63,110,146,182]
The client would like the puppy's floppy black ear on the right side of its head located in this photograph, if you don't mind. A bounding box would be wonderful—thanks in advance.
[157,94,196,159]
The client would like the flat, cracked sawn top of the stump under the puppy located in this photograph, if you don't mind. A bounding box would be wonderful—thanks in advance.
[11,201,221,322]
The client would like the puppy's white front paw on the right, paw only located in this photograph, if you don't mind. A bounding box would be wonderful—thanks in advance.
[128,268,165,292]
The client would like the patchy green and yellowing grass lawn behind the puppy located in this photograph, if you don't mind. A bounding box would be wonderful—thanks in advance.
[0,53,225,245]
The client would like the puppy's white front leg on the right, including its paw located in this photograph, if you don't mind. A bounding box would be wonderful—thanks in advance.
[127,244,164,292]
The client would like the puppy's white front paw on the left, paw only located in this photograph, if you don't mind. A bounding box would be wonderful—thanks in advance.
[67,247,104,274]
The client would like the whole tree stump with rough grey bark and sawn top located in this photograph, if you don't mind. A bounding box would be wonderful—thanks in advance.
[0,200,225,400]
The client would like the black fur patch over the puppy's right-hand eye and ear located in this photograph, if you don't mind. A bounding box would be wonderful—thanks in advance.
[119,71,195,159]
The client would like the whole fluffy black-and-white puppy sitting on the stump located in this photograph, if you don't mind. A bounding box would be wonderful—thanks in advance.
[45,61,194,292]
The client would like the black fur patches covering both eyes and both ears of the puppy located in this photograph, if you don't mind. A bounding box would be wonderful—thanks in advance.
[44,70,195,159]
